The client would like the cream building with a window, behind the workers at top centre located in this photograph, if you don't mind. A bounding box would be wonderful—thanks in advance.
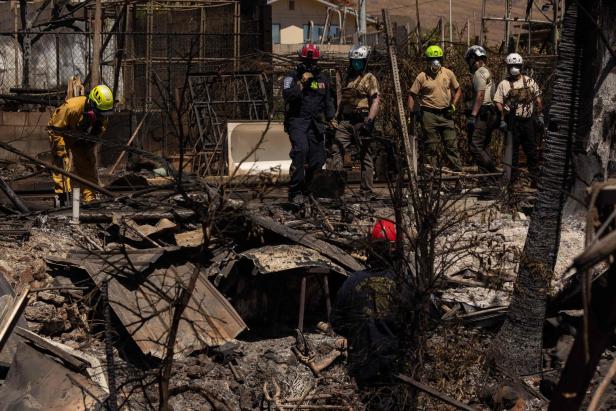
[267,0,376,54]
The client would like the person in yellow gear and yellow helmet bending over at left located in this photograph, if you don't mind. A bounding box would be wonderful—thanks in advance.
[47,85,113,202]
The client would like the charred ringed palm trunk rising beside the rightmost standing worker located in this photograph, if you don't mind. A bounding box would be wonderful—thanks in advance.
[489,0,596,374]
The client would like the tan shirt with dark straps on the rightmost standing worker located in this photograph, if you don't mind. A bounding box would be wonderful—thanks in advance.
[494,75,541,118]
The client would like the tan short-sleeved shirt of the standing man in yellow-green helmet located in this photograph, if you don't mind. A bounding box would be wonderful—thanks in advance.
[410,67,460,109]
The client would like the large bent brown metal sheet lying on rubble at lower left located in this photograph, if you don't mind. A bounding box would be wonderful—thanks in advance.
[54,247,246,358]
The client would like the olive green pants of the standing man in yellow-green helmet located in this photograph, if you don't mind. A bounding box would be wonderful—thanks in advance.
[421,111,462,170]
